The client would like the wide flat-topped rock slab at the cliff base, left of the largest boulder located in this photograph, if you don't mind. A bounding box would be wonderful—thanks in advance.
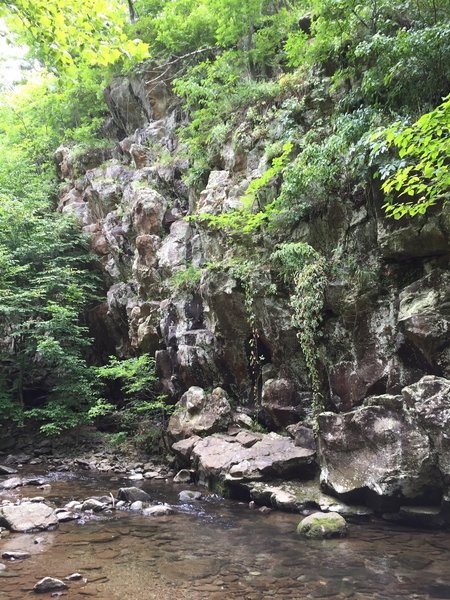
[186,433,315,482]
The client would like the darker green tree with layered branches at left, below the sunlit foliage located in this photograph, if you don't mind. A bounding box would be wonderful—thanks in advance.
[0,192,102,433]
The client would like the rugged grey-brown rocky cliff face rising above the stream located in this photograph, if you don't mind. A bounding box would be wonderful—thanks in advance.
[57,70,450,516]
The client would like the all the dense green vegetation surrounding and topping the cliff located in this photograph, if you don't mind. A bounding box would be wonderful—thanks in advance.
[0,0,450,432]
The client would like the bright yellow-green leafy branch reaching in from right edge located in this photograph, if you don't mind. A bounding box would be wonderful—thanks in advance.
[372,96,450,219]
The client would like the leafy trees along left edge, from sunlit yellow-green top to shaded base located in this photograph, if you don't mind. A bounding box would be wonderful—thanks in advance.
[0,84,103,433]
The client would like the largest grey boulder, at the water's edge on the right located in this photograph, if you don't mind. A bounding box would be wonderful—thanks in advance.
[319,376,450,510]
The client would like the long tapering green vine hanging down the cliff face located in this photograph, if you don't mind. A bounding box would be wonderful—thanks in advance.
[271,242,327,417]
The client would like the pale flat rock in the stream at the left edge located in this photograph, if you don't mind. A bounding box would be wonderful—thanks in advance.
[0,502,58,533]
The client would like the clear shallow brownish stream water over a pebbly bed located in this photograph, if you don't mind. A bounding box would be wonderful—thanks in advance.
[0,473,450,600]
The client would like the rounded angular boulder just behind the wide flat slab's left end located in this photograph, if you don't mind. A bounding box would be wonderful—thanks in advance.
[168,386,232,440]
